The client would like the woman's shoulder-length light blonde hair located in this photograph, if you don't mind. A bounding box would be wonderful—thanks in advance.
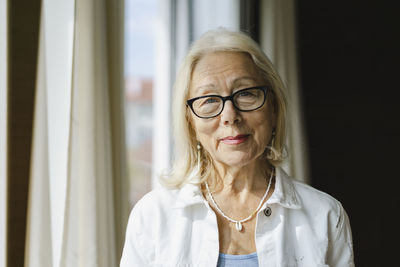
[161,28,286,188]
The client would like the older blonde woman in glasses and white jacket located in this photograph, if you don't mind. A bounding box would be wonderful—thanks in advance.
[121,29,354,267]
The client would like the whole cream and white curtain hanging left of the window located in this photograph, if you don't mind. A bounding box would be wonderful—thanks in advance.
[25,0,129,267]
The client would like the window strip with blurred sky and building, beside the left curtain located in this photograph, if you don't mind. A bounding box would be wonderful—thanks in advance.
[124,0,157,205]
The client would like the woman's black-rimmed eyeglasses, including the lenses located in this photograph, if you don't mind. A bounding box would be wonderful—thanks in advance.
[186,86,268,119]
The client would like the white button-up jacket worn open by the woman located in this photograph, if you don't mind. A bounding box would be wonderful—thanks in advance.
[120,169,354,267]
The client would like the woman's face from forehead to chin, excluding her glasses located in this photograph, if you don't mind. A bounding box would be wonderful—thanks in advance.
[189,52,275,170]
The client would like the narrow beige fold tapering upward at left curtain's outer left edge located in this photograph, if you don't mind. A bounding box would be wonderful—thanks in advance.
[25,17,53,267]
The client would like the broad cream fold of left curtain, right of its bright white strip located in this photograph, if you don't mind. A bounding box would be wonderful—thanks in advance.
[61,0,117,267]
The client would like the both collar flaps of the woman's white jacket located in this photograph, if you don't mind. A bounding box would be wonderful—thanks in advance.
[173,168,301,209]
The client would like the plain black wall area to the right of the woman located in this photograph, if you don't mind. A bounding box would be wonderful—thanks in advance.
[297,0,400,266]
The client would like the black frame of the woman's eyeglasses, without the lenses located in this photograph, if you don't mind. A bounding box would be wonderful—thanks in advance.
[186,85,270,119]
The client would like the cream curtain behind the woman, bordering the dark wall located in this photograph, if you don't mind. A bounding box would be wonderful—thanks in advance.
[260,0,309,182]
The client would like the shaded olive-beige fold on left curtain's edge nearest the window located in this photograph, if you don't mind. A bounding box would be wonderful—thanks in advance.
[106,0,131,260]
